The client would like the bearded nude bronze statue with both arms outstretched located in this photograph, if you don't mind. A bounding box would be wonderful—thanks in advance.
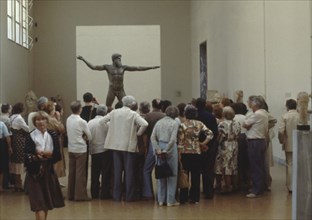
[77,54,160,108]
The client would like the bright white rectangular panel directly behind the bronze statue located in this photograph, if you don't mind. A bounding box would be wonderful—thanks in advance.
[76,25,161,106]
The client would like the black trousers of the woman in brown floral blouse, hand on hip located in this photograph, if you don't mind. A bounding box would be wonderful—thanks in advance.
[180,154,201,203]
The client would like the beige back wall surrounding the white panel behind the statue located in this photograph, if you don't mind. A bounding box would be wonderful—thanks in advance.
[34,1,191,116]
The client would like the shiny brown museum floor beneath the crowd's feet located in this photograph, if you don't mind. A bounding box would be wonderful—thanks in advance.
[0,153,291,220]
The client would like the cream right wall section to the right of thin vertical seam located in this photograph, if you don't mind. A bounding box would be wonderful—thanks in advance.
[265,1,311,163]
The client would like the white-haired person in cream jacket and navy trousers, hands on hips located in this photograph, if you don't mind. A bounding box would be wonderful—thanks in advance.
[99,96,148,202]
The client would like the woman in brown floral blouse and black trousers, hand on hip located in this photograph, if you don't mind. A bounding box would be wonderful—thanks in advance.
[178,105,213,204]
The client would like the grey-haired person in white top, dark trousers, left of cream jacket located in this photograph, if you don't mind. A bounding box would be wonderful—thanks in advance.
[88,105,113,199]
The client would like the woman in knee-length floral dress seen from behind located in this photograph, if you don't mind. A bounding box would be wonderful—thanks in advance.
[215,106,241,193]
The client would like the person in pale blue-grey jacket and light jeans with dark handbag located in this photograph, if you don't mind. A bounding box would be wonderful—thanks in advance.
[151,106,180,206]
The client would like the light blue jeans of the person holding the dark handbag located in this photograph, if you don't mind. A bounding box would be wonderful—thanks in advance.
[157,142,178,204]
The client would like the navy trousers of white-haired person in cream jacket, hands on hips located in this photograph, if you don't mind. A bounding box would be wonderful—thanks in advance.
[113,150,138,202]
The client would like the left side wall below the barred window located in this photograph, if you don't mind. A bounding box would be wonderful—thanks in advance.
[0,1,33,104]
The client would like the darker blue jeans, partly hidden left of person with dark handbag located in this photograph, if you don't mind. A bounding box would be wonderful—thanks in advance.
[142,142,155,198]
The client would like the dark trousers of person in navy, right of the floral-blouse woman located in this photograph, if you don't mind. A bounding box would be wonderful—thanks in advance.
[200,141,217,198]
